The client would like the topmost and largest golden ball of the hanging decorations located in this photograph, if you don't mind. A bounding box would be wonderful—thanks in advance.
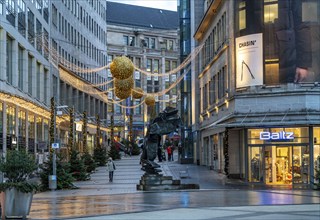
[110,56,134,79]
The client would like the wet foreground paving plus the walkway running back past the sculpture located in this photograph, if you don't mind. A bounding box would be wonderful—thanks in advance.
[28,156,320,220]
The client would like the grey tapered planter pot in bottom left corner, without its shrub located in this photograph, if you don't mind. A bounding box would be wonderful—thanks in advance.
[1,188,33,219]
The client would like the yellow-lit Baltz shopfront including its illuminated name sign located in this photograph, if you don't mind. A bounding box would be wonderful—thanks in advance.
[247,127,320,185]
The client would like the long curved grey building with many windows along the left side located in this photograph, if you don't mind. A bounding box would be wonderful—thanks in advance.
[0,0,107,160]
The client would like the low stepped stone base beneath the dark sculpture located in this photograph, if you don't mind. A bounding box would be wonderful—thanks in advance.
[137,174,199,191]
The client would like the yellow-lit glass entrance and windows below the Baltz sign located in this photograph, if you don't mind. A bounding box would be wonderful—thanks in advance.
[249,145,310,185]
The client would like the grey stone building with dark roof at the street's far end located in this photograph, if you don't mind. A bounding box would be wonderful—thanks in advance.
[107,2,179,139]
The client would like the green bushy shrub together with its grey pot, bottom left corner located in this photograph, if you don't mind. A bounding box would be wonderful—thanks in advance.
[0,150,38,219]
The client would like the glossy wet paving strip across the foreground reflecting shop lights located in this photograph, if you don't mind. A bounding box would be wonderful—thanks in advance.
[29,189,320,219]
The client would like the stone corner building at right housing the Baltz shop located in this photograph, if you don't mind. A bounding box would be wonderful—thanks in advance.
[194,0,320,187]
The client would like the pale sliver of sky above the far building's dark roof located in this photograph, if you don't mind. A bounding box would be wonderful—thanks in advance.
[107,0,177,11]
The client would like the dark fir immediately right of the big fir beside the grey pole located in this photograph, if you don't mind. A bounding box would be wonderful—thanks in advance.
[70,149,90,181]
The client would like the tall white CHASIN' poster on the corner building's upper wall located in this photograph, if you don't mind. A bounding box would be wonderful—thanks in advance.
[236,33,263,88]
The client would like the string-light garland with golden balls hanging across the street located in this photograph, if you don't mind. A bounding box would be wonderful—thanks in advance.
[38,32,204,108]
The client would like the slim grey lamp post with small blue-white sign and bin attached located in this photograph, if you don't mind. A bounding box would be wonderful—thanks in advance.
[49,105,68,190]
